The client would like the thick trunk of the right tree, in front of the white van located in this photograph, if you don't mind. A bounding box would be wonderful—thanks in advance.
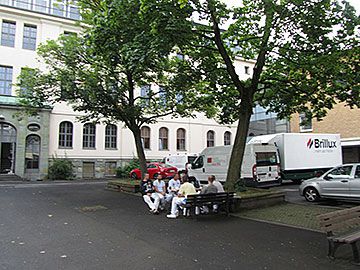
[225,89,253,191]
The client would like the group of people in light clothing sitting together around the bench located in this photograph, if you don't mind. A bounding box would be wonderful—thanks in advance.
[140,173,224,218]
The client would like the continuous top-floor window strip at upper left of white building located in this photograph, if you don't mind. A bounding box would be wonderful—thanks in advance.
[0,0,80,20]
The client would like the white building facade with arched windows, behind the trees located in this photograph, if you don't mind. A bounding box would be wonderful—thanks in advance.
[0,0,253,180]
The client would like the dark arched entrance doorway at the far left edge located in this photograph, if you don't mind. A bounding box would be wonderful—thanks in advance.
[0,123,16,174]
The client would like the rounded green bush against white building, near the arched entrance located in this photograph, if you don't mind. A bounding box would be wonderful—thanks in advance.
[48,158,74,180]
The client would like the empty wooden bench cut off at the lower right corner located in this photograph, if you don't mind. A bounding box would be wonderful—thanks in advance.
[318,206,360,264]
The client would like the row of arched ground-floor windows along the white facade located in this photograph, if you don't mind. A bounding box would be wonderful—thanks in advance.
[59,121,231,151]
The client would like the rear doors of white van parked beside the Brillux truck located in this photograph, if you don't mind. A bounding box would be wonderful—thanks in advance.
[253,151,279,183]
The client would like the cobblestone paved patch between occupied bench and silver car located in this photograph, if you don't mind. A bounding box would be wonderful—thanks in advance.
[234,203,337,231]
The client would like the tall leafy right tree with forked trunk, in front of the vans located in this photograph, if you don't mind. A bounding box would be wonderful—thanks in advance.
[169,0,360,189]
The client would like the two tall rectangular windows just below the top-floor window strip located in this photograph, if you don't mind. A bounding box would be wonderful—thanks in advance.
[0,20,37,51]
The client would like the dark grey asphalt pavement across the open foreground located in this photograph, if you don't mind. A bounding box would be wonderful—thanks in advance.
[0,183,358,270]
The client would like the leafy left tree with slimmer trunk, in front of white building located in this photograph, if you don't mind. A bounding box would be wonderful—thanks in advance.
[19,0,200,177]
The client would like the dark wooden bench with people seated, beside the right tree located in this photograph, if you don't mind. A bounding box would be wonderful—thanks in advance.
[184,192,234,216]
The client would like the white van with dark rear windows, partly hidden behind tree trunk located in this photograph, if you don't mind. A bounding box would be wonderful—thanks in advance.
[188,144,281,187]
